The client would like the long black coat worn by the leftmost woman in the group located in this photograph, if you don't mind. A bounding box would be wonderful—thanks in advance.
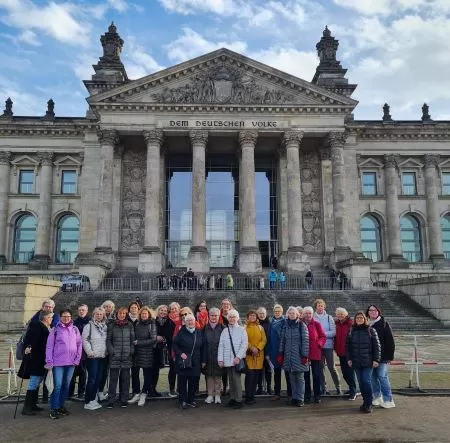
[18,322,50,379]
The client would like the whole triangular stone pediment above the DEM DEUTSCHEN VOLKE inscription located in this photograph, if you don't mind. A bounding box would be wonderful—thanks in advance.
[88,48,358,112]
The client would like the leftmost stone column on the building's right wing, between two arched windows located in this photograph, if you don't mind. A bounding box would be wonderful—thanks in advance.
[384,154,407,267]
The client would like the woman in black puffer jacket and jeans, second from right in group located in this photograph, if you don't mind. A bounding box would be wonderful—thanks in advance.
[346,311,381,413]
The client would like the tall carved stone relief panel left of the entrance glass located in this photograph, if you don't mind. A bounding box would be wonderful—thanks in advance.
[120,147,146,252]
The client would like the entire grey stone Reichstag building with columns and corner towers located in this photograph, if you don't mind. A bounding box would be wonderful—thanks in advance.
[0,23,450,281]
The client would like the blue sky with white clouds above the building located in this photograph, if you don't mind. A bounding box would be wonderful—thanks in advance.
[0,0,450,120]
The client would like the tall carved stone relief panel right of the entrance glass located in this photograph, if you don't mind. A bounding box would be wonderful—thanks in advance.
[300,151,323,252]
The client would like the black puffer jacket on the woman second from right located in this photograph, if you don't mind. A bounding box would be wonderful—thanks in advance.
[347,325,381,368]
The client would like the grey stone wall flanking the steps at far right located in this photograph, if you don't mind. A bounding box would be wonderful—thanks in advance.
[397,275,450,326]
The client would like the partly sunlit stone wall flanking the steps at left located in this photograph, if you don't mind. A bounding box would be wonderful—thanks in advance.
[0,277,60,332]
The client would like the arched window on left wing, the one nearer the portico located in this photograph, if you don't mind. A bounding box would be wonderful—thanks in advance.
[56,215,80,264]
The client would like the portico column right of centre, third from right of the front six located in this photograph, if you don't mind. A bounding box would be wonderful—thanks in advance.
[239,131,262,273]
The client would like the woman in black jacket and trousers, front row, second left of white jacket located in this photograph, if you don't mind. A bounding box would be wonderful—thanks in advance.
[172,314,204,409]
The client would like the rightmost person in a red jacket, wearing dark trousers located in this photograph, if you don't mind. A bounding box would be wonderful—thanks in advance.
[334,308,356,400]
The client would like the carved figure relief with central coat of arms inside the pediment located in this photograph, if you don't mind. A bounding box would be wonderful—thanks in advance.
[152,62,294,104]
